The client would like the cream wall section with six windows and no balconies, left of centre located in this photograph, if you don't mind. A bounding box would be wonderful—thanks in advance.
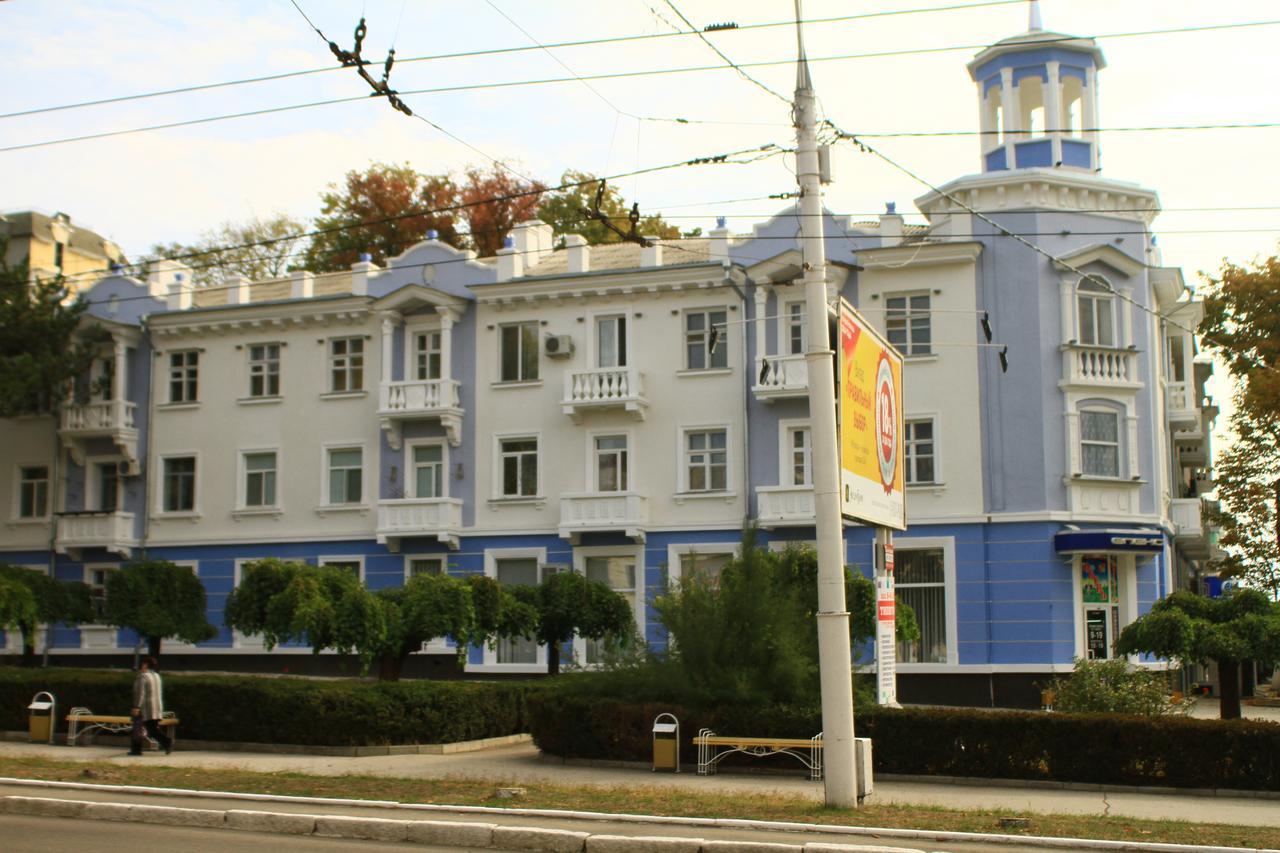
[148,304,381,544]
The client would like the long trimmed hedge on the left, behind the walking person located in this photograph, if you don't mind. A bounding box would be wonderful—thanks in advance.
[0,667,536,747]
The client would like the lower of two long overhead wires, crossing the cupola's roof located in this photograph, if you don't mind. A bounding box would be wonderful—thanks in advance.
[0,19,1280,154]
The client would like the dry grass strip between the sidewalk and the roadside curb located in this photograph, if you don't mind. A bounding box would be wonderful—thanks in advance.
[0,757,1280,849]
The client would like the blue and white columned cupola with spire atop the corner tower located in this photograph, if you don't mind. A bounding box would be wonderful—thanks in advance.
[968,0,1106,172]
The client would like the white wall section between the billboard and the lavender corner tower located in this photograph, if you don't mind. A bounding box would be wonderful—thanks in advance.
[859,247,996,524]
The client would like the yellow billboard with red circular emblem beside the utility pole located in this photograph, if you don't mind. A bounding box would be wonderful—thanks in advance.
[838,300,906,530]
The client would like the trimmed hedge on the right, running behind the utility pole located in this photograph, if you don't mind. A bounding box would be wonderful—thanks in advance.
[527,688,1280,790]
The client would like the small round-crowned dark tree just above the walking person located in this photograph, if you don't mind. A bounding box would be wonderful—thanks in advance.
[102,560,218,657]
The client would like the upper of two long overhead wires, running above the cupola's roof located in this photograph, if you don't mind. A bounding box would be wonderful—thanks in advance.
[0,0,1023,120]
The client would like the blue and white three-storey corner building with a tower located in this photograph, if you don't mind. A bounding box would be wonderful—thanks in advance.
[0,13,1216,704]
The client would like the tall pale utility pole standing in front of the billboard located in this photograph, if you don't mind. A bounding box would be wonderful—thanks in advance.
[792,0,858,808]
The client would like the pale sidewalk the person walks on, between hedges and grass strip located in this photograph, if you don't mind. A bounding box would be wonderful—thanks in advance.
[0,742,1280,826]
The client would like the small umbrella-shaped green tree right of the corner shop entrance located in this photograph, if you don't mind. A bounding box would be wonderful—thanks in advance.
[1116,588,1280,720]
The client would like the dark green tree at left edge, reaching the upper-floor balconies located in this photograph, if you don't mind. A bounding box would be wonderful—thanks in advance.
[0,238,106,418]
